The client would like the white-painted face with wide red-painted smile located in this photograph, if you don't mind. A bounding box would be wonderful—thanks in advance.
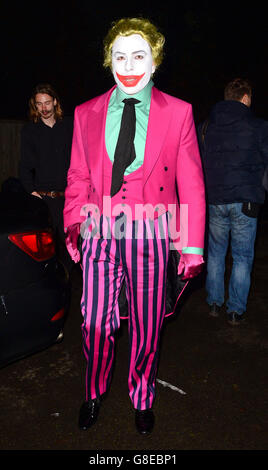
[112,34,155,95]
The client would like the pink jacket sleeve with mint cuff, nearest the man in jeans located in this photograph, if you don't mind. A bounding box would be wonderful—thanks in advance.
[176,104,206,255]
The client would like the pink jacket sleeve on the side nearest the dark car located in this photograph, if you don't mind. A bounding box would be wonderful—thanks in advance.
[63,107,90,231]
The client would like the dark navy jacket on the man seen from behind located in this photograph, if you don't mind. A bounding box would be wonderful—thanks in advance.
[198,100,268,204]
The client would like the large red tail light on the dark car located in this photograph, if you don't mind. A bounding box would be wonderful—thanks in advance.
[8,230,55,261]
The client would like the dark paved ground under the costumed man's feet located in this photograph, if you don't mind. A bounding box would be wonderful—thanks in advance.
[0,211,268,455]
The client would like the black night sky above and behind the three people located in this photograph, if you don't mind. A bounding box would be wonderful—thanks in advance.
[0,0,268,122]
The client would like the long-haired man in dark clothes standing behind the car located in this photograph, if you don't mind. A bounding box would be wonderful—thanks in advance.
[20,83,73,270]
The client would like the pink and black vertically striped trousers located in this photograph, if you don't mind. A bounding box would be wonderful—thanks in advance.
[81,214,169,410]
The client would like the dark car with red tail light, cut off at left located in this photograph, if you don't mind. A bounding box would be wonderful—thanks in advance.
[0,179,70,367]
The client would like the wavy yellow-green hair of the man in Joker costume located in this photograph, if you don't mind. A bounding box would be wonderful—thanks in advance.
[103,18,165,68]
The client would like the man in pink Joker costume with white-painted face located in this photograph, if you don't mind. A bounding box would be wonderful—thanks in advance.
[64,18,205,434]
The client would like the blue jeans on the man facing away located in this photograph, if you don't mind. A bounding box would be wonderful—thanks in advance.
[206,203,257,314]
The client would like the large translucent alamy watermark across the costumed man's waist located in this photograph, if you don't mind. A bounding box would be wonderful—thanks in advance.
[80,196,188,250]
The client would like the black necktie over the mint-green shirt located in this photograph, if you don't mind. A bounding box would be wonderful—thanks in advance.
[111,98,139,197]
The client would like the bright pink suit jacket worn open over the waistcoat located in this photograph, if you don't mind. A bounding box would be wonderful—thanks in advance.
[64,87,205,251]
